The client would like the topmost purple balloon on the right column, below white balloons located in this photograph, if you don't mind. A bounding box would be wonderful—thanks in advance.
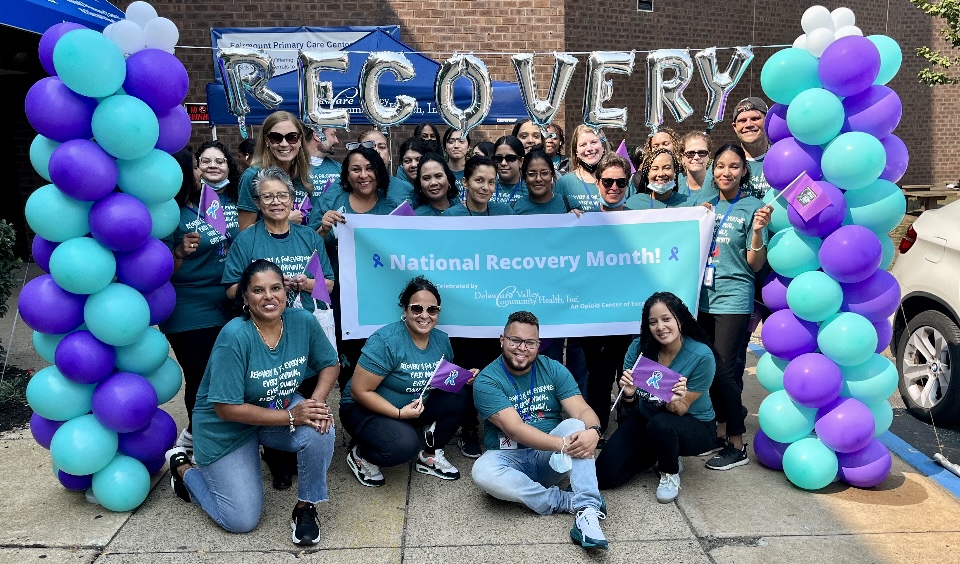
[817,35,880,96]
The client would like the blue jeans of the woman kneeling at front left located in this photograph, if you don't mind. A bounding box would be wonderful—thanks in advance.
[183,394,336,533]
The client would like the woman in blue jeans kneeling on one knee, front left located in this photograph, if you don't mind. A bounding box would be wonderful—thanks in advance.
[167,259,340,545]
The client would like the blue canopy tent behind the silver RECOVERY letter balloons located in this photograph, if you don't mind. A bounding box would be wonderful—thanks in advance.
[207,30,528,126]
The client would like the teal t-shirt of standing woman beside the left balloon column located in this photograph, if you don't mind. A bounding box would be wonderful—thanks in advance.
[160,194,239,334]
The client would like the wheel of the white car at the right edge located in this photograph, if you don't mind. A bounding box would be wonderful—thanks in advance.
[897,311,960,425]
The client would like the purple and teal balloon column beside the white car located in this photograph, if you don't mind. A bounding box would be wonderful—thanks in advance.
[754,6,908,490]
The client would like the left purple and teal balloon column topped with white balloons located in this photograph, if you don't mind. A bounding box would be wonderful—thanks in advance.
[19,2,190,511]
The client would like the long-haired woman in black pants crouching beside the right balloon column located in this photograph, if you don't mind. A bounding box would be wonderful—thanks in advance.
[597,292,717,503]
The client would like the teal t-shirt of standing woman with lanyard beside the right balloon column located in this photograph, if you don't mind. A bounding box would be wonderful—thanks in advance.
[700,193,767,313]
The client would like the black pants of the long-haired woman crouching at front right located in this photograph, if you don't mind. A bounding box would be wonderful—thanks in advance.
[597,411,717,490]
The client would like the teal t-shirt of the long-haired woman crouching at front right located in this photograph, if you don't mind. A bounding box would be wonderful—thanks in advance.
[623,338,717,421]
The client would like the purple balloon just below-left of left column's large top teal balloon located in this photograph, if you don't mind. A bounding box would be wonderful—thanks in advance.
[23,76,97,143]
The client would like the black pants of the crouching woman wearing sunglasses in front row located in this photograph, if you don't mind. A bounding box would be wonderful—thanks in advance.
[340,387,472,468]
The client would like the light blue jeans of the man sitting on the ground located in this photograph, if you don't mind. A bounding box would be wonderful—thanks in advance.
[473,419,600,515]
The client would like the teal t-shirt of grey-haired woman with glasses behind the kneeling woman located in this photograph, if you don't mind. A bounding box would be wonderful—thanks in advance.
[223,221,334,311]
